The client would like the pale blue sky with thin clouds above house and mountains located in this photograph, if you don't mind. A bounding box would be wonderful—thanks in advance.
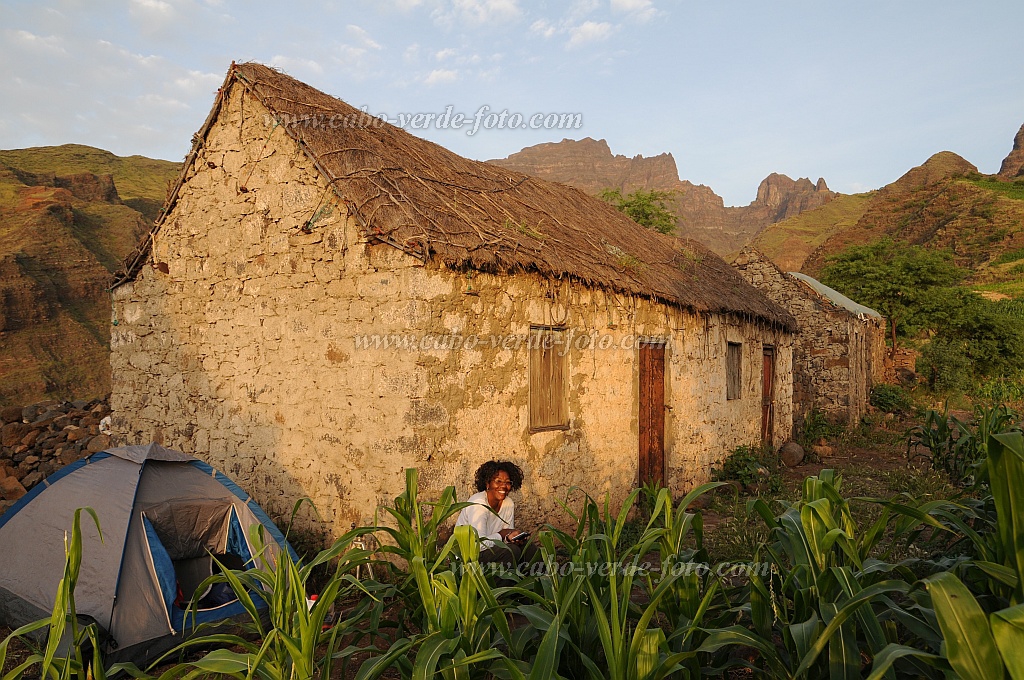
[0,0,1024,205]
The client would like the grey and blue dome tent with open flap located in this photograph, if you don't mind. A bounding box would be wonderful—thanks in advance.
[0,443,295,663]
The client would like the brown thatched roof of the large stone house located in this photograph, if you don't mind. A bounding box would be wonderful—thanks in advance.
[115,63,796,331]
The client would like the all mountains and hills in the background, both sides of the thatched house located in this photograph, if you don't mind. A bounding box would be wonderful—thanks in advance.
[0,121,1024,406]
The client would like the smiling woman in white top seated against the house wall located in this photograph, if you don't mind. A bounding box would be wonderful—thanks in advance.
[455,461,534,565]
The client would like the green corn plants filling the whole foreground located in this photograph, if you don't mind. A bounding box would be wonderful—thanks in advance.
[18,440,1024,680]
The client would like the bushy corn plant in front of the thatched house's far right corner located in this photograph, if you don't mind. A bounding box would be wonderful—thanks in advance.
[698,470,940,678]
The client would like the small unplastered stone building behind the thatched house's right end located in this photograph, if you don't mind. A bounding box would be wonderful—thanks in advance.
[733,247,886,428]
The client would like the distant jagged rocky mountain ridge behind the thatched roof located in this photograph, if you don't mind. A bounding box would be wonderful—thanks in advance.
[487,137,837,255]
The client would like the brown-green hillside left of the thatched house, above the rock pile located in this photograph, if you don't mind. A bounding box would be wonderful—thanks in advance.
[0,144,178,405]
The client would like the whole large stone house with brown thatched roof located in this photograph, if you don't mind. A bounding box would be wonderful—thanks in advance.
[111,63,796,530]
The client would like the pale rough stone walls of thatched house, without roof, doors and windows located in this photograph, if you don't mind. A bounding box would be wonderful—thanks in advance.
[112,88,792,532]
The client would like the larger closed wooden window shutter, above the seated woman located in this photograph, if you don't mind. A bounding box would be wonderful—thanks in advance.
[529,326,569,432]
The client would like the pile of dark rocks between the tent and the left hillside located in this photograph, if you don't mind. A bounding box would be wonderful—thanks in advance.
[0,399,112,512]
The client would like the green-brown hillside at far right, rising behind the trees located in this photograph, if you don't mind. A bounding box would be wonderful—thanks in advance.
[754,128,1024,297]
